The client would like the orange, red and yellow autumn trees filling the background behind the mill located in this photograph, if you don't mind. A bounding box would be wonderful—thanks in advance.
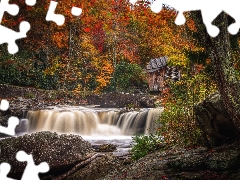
[0,0,205,93]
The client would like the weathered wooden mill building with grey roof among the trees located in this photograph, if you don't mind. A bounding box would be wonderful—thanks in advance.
[146,56,180,91]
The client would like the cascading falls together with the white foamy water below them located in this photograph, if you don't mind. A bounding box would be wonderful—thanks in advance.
[13,106,163,157]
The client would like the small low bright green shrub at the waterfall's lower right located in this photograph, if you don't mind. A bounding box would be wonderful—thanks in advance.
[131,134,163,160]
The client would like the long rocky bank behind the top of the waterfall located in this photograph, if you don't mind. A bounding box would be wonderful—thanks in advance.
[0,84,158,110]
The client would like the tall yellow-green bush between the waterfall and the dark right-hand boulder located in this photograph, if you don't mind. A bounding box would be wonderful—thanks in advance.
[157,73,216,147]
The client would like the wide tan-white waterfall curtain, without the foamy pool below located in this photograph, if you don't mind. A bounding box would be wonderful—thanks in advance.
[26,108,163,136]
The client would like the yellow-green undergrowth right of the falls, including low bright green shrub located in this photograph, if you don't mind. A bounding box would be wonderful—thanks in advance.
[131,69,216,160]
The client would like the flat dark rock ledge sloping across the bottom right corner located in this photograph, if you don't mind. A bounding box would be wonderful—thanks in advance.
[102,141,240,180]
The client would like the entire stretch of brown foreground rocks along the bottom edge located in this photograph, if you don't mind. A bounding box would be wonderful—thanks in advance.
[0,132,240,180]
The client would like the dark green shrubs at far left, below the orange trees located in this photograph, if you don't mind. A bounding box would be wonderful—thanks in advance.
[0,48,58,89]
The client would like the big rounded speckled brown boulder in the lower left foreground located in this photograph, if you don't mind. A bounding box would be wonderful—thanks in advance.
[0,132,96,179]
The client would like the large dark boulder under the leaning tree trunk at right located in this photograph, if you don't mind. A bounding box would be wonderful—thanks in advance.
[194,92,239,147]
